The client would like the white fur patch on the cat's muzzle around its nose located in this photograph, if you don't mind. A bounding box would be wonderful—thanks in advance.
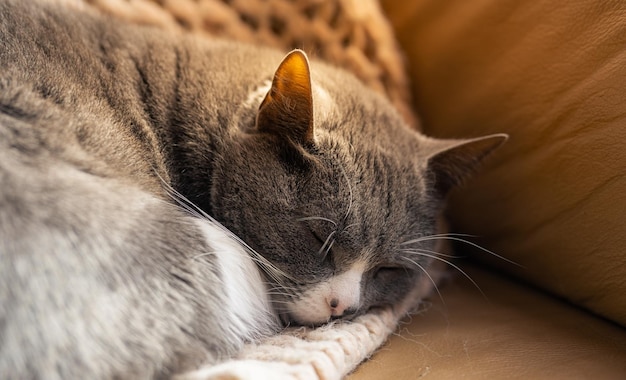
[288,261,367,323]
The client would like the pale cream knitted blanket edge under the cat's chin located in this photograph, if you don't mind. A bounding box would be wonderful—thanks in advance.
[176,271,434,380]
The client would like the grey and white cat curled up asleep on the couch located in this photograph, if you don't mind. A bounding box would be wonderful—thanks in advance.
[0,0,505,379]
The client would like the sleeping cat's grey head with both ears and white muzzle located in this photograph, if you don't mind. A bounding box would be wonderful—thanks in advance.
[211,51,506,324]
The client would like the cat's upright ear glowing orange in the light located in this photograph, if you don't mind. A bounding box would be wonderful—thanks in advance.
[256,50,314,146]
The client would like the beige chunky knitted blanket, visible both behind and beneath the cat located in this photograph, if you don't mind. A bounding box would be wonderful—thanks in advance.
[58,0,426,380]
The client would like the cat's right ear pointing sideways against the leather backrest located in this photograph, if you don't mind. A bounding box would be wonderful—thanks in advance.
[428,134,509,195]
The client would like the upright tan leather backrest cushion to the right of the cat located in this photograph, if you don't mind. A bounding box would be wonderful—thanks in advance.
[383,0,626,325]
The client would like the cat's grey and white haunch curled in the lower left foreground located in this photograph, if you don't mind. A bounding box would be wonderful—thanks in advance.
[0,156,273,379]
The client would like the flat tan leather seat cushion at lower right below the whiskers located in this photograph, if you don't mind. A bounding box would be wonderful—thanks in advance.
[348,267,626,380]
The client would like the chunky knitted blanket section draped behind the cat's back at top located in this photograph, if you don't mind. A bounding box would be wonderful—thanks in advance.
[81,0,417,127]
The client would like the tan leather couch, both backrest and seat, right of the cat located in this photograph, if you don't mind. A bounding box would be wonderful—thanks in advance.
[351,0,626,380]
